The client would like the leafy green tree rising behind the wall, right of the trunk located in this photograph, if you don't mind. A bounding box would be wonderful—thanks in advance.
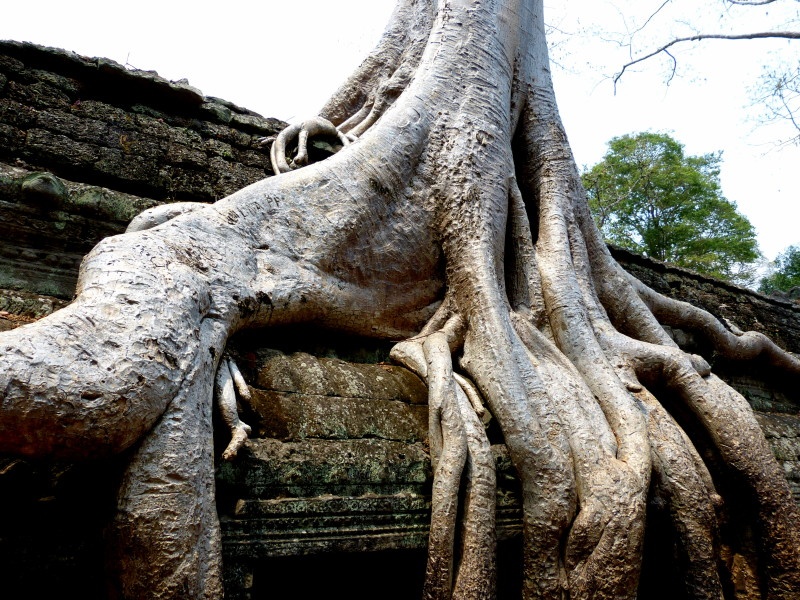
[581,133,760,283]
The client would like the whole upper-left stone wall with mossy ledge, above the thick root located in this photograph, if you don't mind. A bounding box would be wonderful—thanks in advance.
[0,42,285,298]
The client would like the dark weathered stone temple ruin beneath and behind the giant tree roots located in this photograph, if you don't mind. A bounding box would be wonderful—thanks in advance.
[0,42,800,598]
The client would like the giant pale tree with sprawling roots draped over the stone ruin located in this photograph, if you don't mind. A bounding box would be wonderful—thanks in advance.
[0,0,800,599]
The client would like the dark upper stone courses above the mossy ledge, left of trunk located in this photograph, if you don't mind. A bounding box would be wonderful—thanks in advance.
[0,42,285,201]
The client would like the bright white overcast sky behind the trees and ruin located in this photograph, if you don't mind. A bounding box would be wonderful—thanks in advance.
[0,0,800,259]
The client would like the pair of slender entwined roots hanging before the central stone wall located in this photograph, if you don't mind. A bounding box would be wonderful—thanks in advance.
[392,318,496,600]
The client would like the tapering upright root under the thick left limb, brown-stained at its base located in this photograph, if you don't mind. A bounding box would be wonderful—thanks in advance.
[107,344,223,600]
